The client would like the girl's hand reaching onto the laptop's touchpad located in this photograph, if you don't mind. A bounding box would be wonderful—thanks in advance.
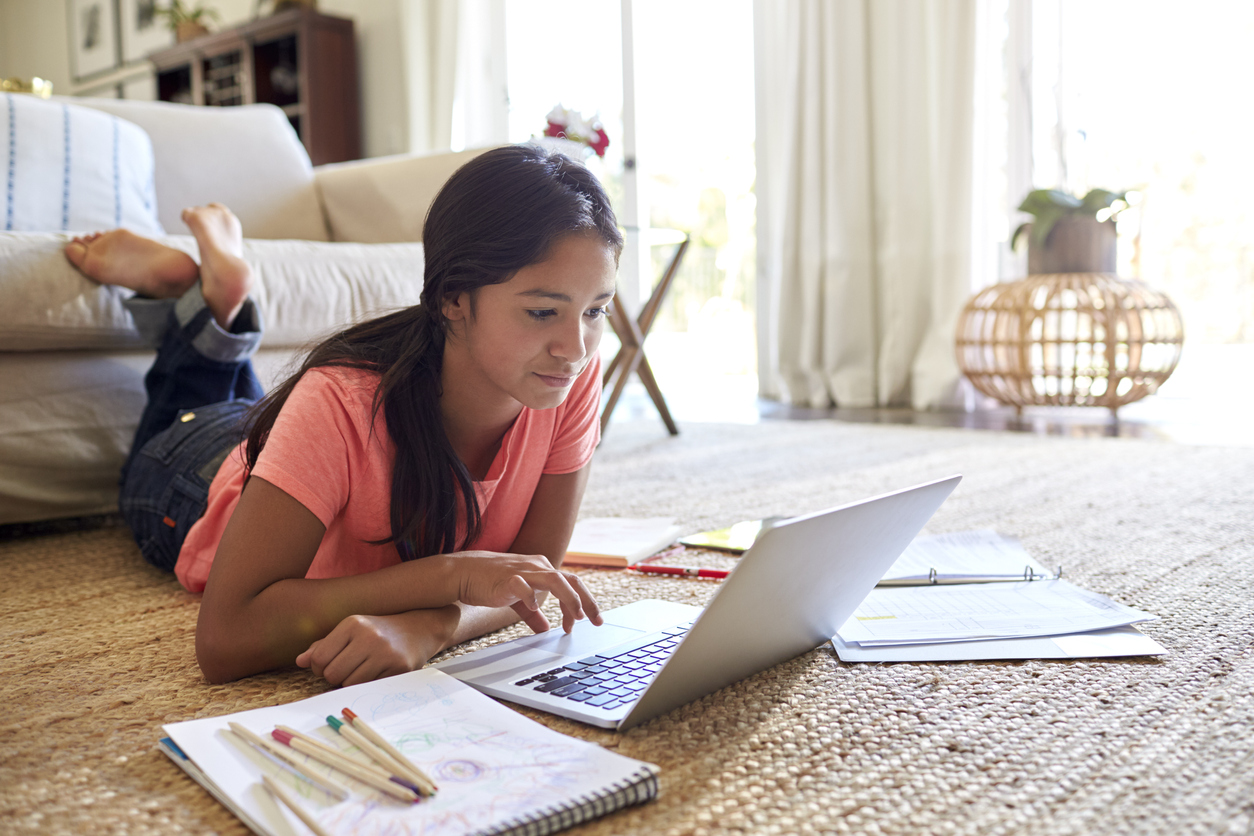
[445,551,602,633]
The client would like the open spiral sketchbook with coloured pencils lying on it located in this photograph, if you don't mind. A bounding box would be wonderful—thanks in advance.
[161,668,658,836]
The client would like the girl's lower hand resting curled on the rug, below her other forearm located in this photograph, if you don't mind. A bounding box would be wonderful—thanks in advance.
[296,607,458,686]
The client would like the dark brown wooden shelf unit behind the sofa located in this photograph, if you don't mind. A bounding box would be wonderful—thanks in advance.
[148,9,361,165]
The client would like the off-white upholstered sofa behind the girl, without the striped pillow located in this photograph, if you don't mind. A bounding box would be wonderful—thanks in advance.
[0,99,489,524]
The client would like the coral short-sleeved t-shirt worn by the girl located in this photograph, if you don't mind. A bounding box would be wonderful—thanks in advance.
[174,358,601,592]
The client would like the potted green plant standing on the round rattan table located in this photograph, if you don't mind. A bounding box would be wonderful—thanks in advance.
[1011,189,1129,276]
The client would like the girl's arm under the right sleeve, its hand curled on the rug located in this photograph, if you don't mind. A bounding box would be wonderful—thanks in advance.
[296,465,601,684]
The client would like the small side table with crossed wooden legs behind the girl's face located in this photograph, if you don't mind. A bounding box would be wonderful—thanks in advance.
[601,229,691,435]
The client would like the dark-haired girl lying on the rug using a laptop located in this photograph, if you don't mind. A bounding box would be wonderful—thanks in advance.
[66,145,622,684]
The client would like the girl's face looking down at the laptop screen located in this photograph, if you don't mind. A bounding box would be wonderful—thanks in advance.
[441,234,616,409]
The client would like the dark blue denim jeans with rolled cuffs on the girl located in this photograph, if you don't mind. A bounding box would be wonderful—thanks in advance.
[118,283,265,569]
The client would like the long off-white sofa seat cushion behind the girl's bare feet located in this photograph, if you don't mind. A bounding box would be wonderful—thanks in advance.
[0,233,423,352]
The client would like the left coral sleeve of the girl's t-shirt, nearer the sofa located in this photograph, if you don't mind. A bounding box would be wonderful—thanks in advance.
[252,368,381,526]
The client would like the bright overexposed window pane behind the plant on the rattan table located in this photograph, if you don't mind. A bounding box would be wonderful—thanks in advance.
[1033,0,1254,345]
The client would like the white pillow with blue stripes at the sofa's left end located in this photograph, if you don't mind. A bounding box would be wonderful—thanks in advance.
[0,93,164,236]
